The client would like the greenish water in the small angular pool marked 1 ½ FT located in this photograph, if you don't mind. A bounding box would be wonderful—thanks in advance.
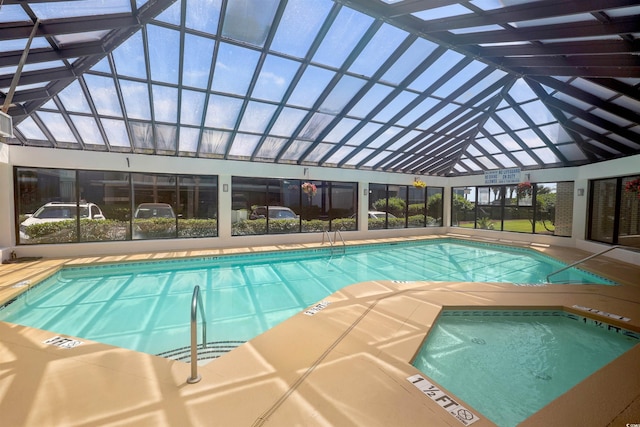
[413,310,640,427]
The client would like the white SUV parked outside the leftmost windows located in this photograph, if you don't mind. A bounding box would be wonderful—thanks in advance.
[20,202,105,239]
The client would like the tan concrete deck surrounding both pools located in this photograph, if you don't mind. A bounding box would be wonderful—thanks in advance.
[0,236,640,427]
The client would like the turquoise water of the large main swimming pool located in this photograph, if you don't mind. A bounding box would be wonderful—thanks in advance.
[0,239,613,354]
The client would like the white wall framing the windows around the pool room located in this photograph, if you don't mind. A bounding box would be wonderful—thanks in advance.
[0,144,640,264]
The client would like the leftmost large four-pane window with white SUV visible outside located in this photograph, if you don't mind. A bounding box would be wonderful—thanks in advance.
[15,167,218,244]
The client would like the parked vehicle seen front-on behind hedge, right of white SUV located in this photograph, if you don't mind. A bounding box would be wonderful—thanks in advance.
[133,203,176,239]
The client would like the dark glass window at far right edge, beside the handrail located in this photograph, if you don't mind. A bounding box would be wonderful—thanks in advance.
[588,175,640,248]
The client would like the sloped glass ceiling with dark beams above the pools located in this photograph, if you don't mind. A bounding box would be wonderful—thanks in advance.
[0,0,640,176]
